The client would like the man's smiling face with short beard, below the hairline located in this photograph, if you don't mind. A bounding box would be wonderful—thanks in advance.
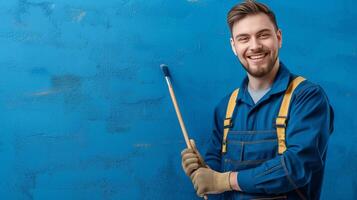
[231,13,282,78]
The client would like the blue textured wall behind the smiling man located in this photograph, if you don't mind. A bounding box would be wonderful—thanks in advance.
[0,0,357,200]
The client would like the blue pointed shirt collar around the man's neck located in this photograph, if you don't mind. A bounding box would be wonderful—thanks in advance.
[237,62,293,106]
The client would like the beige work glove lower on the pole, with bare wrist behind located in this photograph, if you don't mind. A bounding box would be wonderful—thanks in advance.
[191,168,233,197]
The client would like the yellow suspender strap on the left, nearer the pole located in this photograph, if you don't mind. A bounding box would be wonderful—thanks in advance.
[222,88,239,153]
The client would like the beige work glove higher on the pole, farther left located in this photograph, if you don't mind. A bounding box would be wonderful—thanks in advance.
[181,139,207,177]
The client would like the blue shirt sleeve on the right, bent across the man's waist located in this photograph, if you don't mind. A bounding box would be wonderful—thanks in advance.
[237,85,333,194]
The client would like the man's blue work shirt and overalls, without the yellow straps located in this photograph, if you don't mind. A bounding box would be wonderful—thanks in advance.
[205,63,333,199]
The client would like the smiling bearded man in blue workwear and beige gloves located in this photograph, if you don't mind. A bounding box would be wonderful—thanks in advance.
[181,0,334,199]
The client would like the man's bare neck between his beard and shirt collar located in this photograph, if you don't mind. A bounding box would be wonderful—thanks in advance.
[248,58,279,90]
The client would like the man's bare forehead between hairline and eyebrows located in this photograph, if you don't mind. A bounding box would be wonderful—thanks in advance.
[232,13,275,37]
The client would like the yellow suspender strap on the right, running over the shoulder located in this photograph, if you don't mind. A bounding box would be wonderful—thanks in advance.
[275,76,305,154]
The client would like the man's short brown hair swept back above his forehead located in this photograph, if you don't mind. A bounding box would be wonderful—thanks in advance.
[227,0,278,33]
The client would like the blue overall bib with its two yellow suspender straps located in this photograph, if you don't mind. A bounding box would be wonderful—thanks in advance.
[221,77,305,200]
